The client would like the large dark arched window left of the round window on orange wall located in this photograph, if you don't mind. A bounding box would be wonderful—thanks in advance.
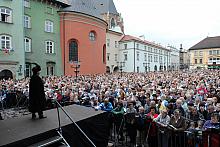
[69,40,78,61]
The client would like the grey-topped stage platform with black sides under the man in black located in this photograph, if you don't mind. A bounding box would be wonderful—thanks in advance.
[0,105,108,147]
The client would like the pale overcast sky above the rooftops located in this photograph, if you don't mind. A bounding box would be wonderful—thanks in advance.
[114,0,220,49]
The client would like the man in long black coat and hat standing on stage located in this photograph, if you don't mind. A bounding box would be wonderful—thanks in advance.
[29,65,46,119]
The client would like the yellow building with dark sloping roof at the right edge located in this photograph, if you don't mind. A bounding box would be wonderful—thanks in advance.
[189,36,220,69]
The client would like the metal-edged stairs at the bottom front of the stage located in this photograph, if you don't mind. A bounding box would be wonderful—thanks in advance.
[29,136,68,147]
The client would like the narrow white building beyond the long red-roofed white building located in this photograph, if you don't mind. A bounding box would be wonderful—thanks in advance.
[167,45,180,70]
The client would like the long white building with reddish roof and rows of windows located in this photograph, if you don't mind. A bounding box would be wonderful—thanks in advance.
[118,35,170,72]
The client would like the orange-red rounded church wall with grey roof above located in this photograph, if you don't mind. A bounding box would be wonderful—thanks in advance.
[59,0,107,77]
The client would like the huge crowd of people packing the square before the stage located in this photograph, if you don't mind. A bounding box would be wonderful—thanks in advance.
[0,70,220,146]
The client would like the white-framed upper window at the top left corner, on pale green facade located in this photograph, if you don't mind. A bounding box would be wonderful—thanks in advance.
[0,7,12,23]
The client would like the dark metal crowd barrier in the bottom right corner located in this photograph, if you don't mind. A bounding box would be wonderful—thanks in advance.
[157,125,220,147]
